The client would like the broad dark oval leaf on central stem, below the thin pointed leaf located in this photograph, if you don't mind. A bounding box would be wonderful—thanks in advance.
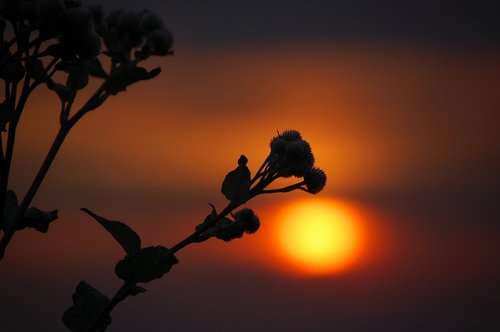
[115,246,179,283]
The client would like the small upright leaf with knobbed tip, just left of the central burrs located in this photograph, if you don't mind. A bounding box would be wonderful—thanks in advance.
[221,155,250,203]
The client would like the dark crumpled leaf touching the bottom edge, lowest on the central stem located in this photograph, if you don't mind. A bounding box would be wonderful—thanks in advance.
[63,281,111,332]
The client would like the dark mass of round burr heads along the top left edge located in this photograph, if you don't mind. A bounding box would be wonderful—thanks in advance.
[0,0,173,61]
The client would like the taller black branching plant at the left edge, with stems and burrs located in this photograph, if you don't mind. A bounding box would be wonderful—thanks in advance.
[0,0,172,259]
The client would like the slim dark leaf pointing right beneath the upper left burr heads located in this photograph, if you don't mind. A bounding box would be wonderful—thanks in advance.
[106,65,161,95]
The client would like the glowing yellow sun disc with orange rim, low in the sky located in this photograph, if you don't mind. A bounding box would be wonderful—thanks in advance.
[276,198,361,274]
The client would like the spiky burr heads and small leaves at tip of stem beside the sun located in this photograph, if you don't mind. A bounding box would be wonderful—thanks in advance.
[196,130,326,242]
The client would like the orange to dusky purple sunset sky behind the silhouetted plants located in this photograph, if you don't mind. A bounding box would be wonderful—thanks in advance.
[0,0,500,332]
